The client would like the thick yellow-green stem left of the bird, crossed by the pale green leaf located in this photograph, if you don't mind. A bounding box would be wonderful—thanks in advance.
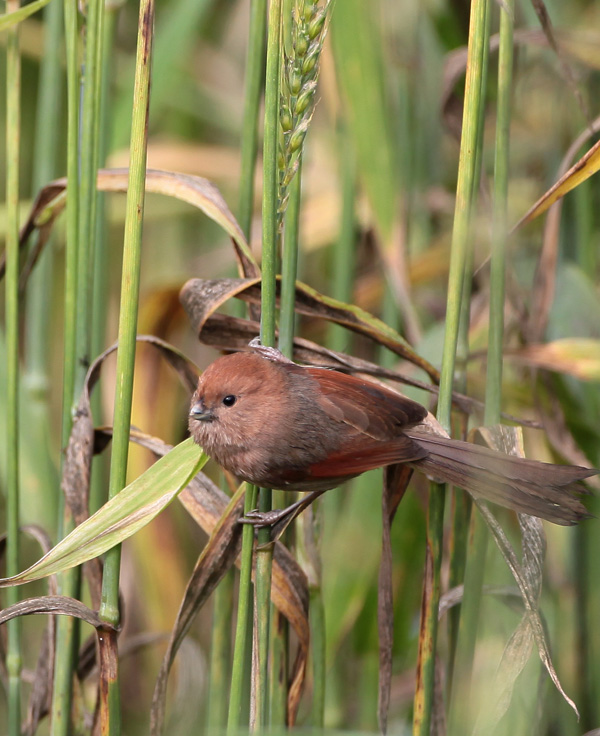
[99,0,154,734]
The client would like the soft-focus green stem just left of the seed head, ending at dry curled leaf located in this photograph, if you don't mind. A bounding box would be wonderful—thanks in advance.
[238,0,267,241]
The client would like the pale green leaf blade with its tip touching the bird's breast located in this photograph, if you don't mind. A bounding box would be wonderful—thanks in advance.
[0,437,208,587]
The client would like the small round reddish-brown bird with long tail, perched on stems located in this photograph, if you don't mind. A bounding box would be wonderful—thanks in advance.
[189,348,599,525]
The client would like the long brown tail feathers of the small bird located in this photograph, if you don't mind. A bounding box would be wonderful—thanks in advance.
[406,430,600,526]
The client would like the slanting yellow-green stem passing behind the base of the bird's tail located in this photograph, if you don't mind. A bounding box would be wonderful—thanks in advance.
[413,0,487,736]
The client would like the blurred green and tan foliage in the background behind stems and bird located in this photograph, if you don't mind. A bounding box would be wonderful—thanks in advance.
[0,0,600,736]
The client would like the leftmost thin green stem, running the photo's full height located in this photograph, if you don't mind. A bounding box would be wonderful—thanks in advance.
[4,0,21,736]
